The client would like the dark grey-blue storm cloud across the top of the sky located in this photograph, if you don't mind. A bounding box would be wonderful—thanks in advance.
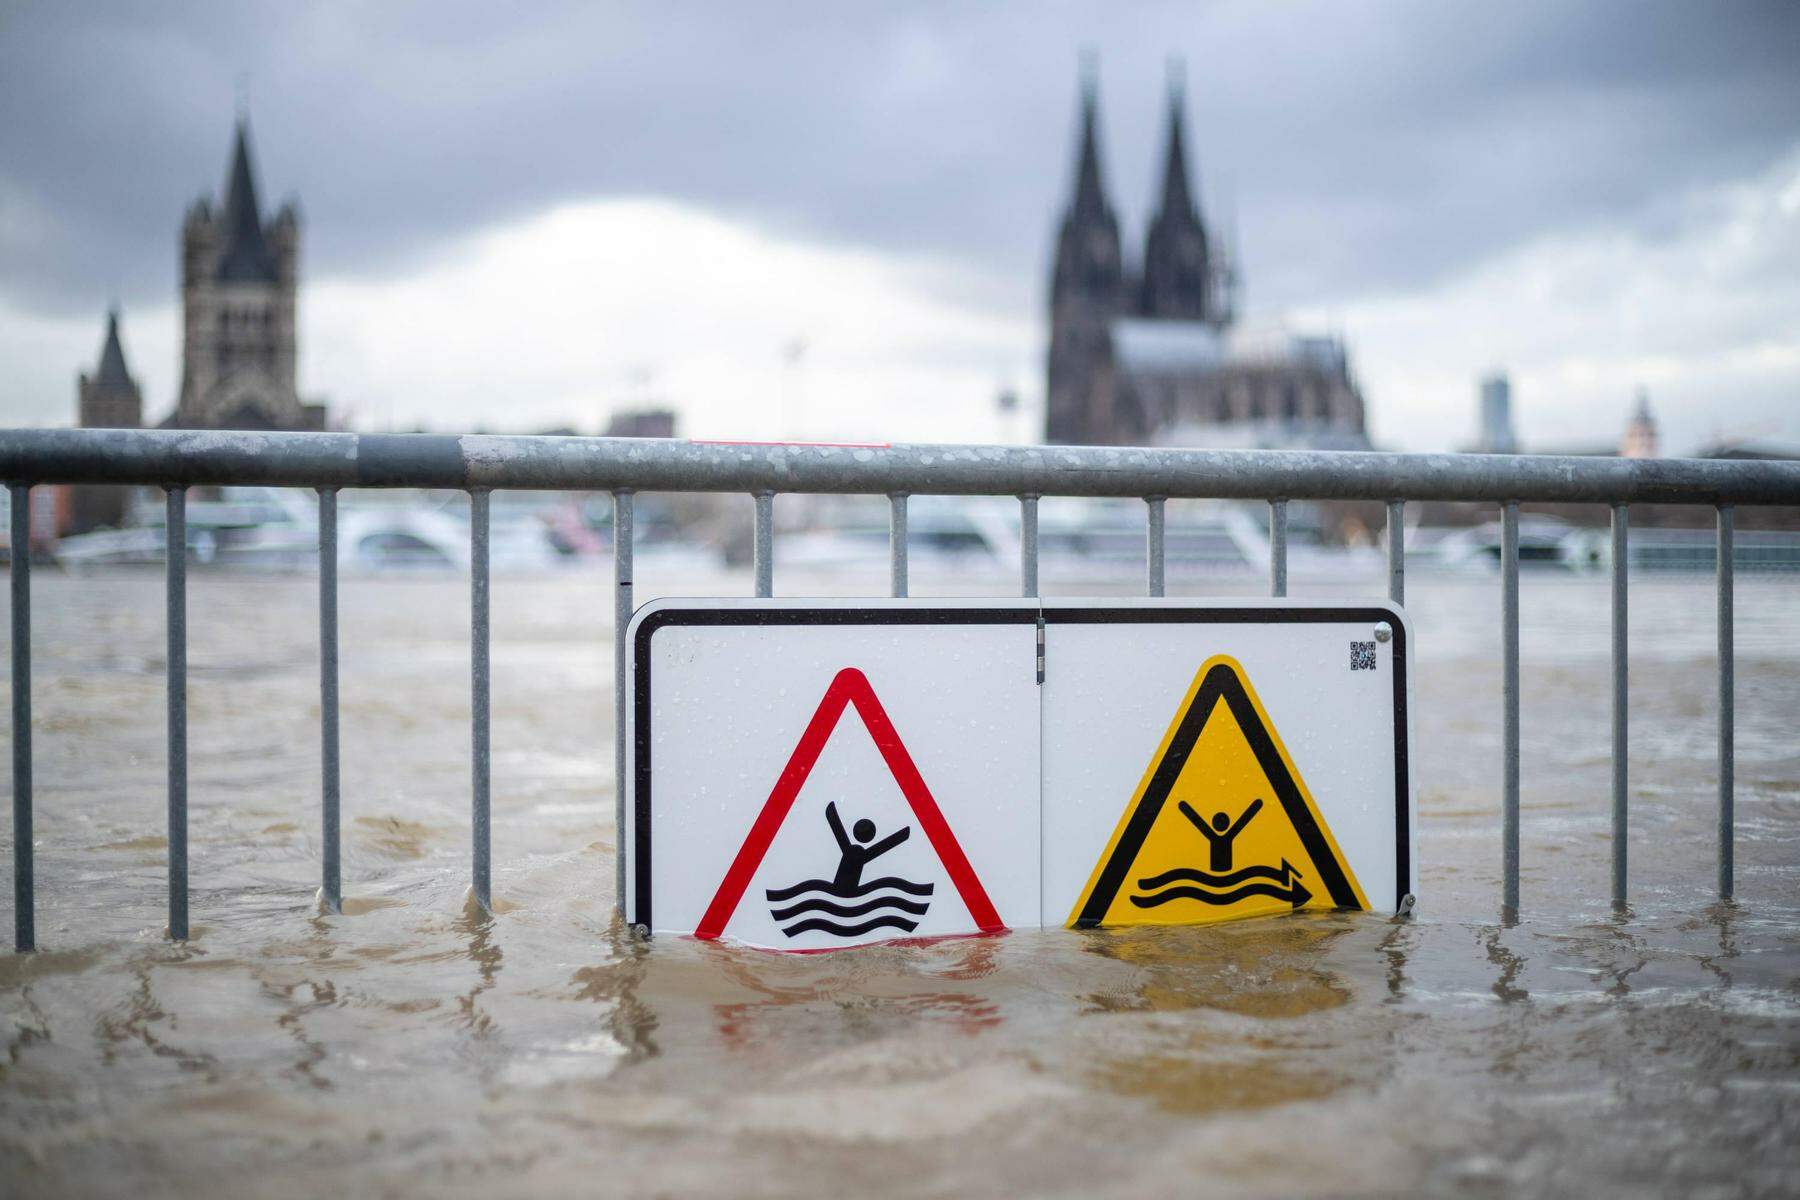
[0,4,1800,322]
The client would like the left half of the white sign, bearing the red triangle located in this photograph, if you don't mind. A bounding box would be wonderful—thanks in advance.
[625,601,1040,950]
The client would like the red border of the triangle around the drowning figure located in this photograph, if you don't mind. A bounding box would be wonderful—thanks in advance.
[693,667,1006,937]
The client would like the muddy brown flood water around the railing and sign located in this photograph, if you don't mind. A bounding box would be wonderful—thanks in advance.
[0,569,1800,1196]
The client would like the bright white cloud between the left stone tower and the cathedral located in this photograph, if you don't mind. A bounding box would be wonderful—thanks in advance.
[302,200,1037,441]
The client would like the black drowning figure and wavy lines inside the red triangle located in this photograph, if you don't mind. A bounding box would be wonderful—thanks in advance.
[765,801,936,937]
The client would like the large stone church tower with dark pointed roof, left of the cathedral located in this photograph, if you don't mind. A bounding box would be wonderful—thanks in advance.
[169,121,324,430]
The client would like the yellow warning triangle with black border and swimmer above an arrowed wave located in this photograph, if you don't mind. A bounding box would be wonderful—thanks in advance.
[1069,655,1368,927]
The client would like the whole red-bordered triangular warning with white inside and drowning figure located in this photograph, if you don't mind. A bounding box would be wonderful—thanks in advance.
[695,667,1004,948]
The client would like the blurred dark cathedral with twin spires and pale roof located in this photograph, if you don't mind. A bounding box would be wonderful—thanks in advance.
[1044,67,1368,450]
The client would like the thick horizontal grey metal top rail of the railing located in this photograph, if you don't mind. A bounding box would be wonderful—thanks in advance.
[0,430,1800,504]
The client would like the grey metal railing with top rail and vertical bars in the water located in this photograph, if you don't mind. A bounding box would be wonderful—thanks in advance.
[0,430,1800,950]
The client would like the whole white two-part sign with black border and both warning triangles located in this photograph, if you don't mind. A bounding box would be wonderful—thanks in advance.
[621,601,1413,950]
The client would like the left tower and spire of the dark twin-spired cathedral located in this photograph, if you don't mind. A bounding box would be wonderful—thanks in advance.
[1044,74,1125,444]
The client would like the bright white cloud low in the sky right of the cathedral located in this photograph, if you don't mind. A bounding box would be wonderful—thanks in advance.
[1312,153,1800,453]
